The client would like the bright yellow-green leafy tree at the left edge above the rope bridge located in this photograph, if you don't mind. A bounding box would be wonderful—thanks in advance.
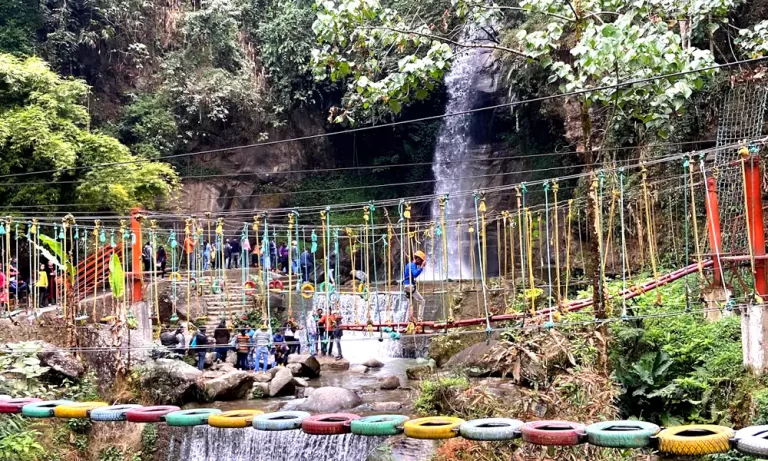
[0,54,178,210]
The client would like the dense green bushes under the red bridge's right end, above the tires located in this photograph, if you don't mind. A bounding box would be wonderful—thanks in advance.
[609,274,747,425]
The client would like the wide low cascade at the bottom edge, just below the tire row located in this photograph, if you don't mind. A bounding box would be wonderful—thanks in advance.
[166,426,386,461]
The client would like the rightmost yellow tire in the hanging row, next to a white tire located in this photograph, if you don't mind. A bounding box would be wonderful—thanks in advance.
[657,424,733,456]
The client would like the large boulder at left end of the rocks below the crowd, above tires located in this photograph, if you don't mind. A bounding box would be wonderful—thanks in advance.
[137,359,203,405]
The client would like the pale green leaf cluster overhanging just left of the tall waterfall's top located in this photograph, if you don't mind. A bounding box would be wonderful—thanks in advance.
[312,0,453,124]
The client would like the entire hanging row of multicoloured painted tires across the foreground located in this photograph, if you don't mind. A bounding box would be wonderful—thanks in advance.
[0,399,768,456]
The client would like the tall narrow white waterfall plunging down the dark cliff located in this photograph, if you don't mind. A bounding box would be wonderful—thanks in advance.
[422,34,490,280]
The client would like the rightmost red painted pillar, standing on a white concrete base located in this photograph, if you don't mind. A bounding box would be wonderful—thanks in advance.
[742,153,768,299]
